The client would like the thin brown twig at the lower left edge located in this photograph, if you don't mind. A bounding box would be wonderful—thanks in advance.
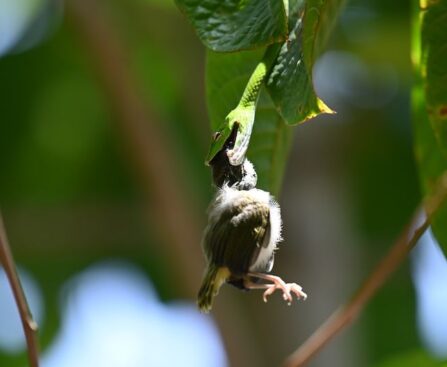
[0,213,39,367]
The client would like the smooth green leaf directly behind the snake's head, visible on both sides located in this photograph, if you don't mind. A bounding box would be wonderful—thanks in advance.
[206,50,292,195]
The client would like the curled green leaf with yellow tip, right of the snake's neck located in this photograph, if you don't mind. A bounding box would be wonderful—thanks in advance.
[267,0,342,124]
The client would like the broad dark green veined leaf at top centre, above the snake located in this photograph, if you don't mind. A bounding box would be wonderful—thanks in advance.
[176,0,287,52]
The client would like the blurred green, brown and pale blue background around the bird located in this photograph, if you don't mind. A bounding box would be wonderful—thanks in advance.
[0,0,447,367]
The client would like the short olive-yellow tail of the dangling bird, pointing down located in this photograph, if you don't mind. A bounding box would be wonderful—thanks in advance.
[197,265,230,313]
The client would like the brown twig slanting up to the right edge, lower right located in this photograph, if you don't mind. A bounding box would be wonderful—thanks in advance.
[284,174,447,367]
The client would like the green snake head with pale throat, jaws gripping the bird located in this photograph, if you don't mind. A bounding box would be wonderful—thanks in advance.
[205,108,255,166]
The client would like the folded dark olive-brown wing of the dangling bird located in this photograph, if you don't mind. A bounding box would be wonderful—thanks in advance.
[204,191,270,275]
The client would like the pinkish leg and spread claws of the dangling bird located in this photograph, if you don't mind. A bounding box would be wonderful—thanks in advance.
[244,273,307,305]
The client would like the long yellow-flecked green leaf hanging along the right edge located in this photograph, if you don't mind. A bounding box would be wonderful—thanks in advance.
[412,0,447,253]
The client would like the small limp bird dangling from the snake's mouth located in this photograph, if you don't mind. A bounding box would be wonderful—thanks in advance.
[197,157,307,313]
